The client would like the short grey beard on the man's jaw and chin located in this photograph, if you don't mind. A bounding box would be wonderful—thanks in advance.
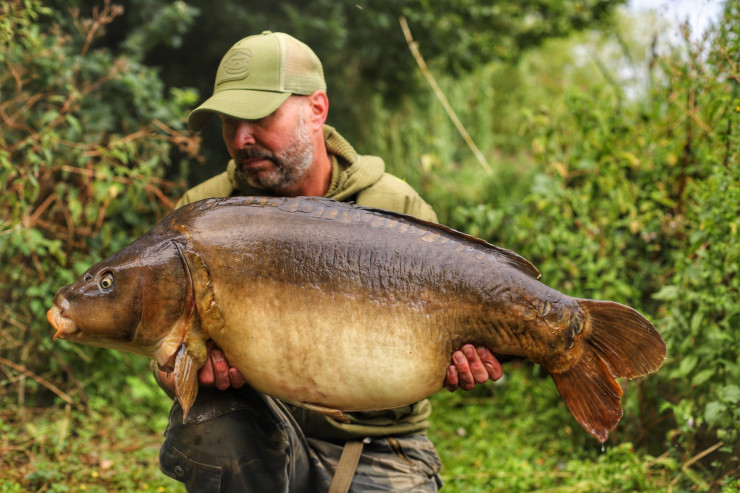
[235,115,314,194]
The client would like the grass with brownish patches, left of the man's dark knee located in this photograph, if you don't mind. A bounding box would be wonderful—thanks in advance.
[0,406,184,493]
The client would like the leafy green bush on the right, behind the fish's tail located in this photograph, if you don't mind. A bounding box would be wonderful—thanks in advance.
[452,1,740,488]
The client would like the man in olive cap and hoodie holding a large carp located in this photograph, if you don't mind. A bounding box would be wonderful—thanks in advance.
[158,32,501,492]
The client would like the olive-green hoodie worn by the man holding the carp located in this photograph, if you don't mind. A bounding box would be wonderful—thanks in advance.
[176,125,437,440]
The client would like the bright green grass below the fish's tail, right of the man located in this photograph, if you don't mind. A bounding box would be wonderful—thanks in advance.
[422,365,678,493]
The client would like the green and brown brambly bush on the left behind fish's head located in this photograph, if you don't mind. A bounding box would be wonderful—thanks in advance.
[0,1,198,444]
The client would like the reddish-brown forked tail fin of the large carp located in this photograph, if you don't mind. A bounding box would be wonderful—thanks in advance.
[550,299,666,443]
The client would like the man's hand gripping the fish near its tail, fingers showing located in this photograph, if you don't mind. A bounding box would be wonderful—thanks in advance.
[445,344,503,392]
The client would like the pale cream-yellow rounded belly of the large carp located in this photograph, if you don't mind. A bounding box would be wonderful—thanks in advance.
[212,281,451,411]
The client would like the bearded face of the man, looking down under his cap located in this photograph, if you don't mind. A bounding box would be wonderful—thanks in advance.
[221,97,314,194]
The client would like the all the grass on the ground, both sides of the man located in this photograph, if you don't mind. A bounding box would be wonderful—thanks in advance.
[0,365,684,493]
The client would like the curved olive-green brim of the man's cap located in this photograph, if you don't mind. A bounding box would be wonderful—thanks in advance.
[188,89,291,132]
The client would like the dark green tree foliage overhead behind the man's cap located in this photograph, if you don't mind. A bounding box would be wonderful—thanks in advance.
[78,0,625,184]
